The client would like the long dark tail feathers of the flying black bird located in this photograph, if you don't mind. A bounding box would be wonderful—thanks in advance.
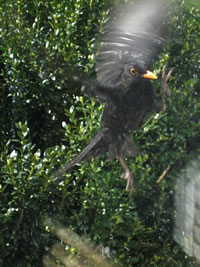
[54,130,107,182]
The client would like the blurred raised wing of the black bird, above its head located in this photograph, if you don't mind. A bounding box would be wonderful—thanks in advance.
[96,0,166,87]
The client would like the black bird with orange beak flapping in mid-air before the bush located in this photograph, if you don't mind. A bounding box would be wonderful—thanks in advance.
[56,0,171,191]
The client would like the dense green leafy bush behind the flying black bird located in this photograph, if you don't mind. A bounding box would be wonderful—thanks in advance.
[0,0,200,266]
